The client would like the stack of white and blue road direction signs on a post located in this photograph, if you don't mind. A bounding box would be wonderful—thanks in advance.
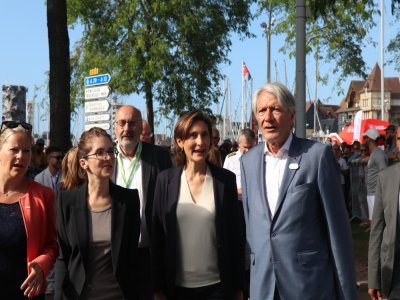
[84,68,111,133]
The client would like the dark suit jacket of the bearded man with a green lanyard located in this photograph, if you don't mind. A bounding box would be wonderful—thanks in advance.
[113,142,172,238]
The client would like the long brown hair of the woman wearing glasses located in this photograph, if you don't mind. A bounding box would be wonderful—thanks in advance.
[62,127,113,189]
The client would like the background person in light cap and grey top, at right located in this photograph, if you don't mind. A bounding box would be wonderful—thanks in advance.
[363,128,388,224]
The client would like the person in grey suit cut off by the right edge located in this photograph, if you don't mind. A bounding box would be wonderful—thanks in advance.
[368,128,400,300]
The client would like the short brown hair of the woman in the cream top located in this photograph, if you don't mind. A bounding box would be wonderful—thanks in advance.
[173,110,212,167]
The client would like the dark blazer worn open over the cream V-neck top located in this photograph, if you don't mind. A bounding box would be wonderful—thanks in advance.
[150,164,244,299]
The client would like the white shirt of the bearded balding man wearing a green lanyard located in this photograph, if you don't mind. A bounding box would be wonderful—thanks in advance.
[115,145,149,247]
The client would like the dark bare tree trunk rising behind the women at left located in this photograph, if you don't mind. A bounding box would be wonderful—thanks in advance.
[47,0,71,151]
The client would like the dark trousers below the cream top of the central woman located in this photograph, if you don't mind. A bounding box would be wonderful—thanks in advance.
[174,283,226,300]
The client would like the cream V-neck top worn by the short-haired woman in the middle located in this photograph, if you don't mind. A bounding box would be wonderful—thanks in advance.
[175,169,220,288]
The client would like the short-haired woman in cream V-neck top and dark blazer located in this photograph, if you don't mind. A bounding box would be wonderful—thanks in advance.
[151,111,244,300]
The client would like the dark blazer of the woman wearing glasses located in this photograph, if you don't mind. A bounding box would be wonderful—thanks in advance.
[57,182,140,300]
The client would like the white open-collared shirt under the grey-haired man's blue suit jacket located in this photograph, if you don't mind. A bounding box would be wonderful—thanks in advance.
[264,133,293,216]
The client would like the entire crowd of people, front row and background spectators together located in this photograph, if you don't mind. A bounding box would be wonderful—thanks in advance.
[0,83,400,300]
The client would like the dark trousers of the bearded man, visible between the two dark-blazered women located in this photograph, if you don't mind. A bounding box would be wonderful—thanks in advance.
[137,248,153,300]
